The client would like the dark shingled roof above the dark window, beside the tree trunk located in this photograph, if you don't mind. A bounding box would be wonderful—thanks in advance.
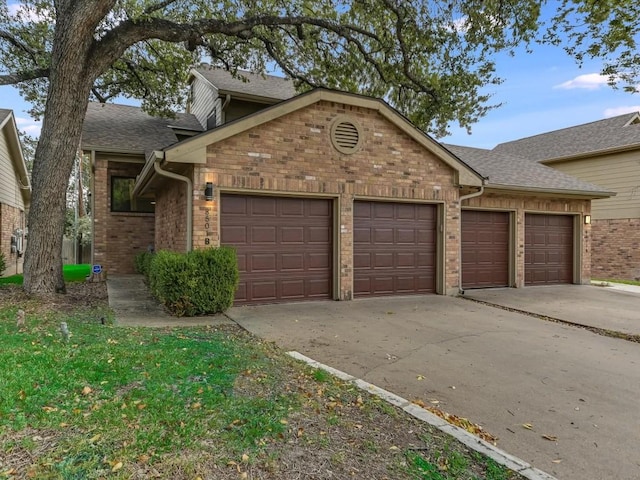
[82,102,202,153]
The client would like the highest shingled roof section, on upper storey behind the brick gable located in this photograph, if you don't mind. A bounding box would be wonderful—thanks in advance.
[193,65,296,101]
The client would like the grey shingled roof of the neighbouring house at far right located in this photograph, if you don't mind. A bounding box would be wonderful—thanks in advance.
[493,112,640,161]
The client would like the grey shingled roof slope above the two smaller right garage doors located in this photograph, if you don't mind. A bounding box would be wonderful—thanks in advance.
[445,145,615,198]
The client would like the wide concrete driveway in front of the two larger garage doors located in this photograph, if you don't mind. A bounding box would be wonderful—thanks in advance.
[229,295,640,480]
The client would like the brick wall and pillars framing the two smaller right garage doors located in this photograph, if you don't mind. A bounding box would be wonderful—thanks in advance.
[463,193,592,287]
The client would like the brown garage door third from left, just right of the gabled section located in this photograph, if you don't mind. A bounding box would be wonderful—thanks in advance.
[462,210,509,288]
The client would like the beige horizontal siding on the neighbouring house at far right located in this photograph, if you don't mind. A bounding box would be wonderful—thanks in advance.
[549,150,640,220]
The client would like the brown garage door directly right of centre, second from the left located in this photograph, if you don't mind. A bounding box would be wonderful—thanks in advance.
[353,201,437,297]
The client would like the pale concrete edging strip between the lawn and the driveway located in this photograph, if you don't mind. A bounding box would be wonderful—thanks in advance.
[287,351,557,480]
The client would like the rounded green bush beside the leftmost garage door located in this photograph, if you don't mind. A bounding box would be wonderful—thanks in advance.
[149,247,239,317]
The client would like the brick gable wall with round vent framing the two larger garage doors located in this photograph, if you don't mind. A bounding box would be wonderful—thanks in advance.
[193,102,460,299]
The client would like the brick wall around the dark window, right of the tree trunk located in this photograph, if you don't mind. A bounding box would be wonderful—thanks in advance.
[93,158,154,273]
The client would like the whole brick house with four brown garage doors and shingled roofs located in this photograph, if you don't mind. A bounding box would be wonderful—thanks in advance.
[83,67,609,303]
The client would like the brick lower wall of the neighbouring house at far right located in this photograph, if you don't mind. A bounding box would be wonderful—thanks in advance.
[591,218,640,280]
